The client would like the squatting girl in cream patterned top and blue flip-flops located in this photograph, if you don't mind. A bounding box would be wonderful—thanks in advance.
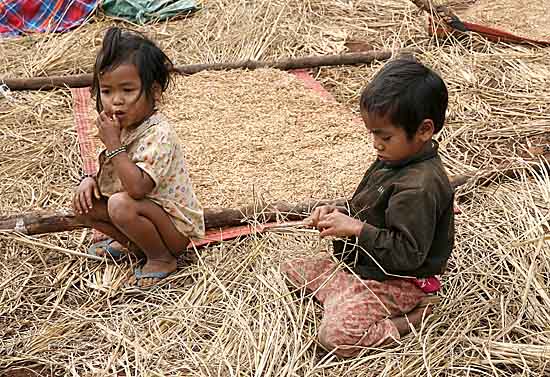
[73,28,204,287]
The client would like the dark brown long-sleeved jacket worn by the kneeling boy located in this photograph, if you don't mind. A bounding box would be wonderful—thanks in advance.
[333,141,454,281]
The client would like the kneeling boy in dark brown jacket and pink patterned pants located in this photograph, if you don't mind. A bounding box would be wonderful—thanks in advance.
[281,59,454,357]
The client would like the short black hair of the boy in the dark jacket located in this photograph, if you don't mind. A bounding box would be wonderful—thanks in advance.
[360,58,449,138]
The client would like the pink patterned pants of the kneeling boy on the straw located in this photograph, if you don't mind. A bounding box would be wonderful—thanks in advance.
[281,255,426,357]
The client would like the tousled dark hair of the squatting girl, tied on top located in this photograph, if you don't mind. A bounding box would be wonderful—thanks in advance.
[92,27,173,112]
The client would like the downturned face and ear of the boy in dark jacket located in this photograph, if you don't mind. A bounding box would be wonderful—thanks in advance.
[361,111,434,162]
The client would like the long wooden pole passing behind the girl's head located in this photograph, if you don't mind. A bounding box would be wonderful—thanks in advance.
[0,49,420,90]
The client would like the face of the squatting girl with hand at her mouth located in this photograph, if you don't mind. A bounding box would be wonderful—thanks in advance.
[99,64,154,128]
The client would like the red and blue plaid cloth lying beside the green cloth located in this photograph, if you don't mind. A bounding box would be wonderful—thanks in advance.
[0,0,98,36]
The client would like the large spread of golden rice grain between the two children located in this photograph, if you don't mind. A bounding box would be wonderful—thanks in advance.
[168,70,373,207]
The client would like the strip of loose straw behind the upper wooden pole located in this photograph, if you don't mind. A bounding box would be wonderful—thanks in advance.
[0,0,426,77]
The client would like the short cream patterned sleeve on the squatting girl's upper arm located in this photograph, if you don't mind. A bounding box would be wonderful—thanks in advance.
[132,127,174,187]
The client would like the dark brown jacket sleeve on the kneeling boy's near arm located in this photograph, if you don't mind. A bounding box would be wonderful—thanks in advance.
[358,188,438,271]
